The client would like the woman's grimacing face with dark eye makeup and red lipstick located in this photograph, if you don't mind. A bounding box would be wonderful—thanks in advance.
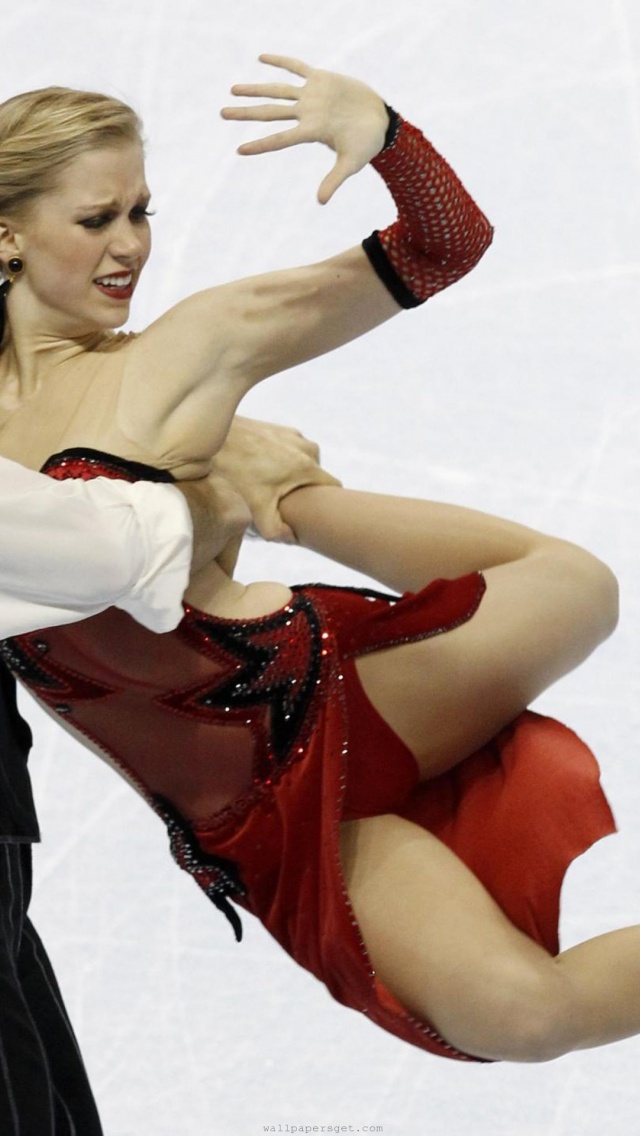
[10,142,151,335]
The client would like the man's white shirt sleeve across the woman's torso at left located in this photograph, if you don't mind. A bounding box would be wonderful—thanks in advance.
[0,458,192,637]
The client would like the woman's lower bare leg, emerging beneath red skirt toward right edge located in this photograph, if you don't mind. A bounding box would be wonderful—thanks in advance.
[342,817,640,1061]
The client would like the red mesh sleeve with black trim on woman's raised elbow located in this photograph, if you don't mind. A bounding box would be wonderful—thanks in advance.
[363,109,493,308]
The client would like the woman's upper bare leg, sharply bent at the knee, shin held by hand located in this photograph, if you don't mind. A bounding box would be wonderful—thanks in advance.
[282,486,617,778]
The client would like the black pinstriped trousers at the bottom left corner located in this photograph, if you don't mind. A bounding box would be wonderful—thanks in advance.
[0,842,102,1136]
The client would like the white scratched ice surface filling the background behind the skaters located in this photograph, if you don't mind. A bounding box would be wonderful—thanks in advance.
[0,0,640,1136]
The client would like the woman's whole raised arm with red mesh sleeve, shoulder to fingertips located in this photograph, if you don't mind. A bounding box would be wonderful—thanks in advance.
[123,56,491,460]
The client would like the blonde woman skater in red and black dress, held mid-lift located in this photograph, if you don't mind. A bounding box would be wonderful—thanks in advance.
[0,56,627,1061]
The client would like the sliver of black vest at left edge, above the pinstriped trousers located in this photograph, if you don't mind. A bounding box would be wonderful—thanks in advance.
[0,662,40,843]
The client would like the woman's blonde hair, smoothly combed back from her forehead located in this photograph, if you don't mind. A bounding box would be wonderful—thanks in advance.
[0,86,142,217]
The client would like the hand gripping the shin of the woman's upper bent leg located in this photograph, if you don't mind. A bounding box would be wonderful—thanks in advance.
[213,416,340,540]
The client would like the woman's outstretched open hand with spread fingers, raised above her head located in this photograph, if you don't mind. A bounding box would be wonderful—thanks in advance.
[222,55,389,204]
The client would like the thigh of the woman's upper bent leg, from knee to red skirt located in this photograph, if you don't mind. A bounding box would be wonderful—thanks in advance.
[356,557,612,778]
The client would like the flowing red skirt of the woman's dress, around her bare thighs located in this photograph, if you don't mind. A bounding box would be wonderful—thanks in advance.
[184,576,615,1060]
